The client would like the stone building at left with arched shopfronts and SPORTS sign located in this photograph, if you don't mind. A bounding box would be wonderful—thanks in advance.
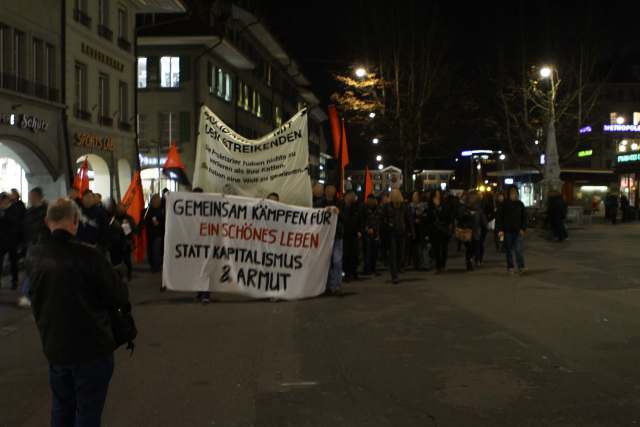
[0,0,185,198]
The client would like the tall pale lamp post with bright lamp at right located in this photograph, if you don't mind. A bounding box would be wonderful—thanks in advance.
[540,67,562,200]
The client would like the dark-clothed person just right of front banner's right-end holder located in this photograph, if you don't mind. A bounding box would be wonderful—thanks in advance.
[342,191,362,282]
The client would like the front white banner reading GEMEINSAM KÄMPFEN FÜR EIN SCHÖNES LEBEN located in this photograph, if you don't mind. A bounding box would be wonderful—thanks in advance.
[162,193,337,299]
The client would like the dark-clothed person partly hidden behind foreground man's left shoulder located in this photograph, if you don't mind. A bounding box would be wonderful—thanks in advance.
[18,187,49,308]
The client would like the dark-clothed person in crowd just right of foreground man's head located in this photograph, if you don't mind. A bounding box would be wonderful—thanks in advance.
[77,190,109,254]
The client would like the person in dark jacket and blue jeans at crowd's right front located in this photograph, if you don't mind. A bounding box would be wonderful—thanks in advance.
[496,187,527,273]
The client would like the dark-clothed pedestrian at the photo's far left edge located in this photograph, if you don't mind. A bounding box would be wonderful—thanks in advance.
[0,192,25,290]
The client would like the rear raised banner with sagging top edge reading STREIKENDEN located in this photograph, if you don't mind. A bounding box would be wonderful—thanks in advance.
[193,105,311,206]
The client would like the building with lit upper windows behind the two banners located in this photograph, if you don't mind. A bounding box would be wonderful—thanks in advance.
[137,6,326,196]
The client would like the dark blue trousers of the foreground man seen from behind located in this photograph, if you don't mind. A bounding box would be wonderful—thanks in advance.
[49,354,113,427]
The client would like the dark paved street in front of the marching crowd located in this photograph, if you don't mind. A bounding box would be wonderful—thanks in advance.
[0,224,640,427]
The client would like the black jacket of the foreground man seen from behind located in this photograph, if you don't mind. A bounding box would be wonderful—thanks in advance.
[27,230,129,365]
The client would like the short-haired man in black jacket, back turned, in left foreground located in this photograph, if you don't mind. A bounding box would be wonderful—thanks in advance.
[26,199,130,426]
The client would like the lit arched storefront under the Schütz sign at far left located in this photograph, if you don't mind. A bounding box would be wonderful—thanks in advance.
[0,98,69,200]
